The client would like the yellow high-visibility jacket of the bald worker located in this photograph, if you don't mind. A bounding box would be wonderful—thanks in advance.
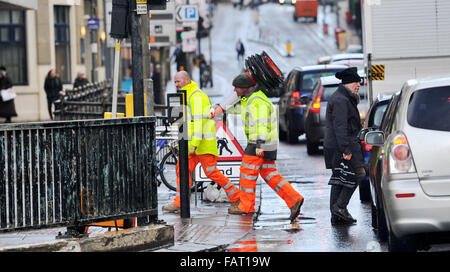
[182,80,219,157]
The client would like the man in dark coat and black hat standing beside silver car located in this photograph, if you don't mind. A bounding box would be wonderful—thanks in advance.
[324,67,366,225]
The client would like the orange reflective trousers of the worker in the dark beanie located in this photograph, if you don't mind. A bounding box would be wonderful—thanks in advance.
[238,155,303,213]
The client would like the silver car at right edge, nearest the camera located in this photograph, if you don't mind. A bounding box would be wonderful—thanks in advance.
[365,77,450,251]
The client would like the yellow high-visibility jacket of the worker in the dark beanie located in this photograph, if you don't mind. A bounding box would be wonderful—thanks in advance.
[241,90,278,161]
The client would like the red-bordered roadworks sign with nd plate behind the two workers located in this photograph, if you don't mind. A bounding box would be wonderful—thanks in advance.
[195,121,244,181]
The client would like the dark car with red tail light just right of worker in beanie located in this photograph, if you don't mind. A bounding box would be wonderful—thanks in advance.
[279,65,348,143]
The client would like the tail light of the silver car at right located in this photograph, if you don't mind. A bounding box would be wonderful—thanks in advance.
[389,133,416,174]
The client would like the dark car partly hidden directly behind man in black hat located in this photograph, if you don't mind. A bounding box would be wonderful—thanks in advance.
[303,74,369,155]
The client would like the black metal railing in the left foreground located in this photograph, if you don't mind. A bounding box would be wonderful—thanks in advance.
[0,117,158,231]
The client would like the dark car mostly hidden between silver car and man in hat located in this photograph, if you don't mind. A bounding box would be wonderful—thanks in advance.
[358,94,392,202]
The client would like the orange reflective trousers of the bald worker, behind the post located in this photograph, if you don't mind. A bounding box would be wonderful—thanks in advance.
[172,154,240,207]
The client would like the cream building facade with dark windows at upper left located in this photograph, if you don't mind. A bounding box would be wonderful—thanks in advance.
[0,0,106,122]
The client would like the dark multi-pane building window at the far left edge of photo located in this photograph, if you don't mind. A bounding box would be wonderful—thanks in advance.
[0,10,28,85]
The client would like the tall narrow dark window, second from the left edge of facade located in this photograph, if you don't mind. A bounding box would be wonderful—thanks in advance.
[54,6,72,83]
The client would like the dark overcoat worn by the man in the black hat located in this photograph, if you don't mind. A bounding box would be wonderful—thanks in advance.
[323,84,364,169]
